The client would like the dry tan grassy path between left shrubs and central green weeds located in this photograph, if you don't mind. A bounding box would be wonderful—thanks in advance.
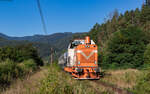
[1,68,48,94]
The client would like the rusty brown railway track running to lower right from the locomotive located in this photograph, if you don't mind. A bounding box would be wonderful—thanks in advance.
[92,80,133,94]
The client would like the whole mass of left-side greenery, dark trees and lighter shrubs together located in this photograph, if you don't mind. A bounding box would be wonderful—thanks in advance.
[0,44,43,89]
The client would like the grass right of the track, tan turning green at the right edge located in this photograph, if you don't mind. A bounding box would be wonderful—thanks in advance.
[100,69,150,94]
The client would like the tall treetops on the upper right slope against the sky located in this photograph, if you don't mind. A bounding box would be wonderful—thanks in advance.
[89,5,150,47]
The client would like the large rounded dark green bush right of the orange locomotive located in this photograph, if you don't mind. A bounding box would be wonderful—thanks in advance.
[102,27,148,68]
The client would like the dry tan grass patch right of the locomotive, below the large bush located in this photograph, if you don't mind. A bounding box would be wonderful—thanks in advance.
[101,69,142,88]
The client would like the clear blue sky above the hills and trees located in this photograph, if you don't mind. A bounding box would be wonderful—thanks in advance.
[0,0,143,37]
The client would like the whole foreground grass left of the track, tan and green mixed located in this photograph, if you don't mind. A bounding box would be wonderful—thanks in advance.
[2,65,113,94]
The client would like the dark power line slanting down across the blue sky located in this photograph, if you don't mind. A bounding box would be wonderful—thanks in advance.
[36,0,48,35]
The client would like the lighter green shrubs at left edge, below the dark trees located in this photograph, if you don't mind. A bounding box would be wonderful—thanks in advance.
[0,59,38,90]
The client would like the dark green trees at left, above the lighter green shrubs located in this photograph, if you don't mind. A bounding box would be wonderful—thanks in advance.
[0,44,43,66]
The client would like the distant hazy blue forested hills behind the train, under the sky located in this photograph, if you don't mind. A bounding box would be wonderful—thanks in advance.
[0,32,85,58]
